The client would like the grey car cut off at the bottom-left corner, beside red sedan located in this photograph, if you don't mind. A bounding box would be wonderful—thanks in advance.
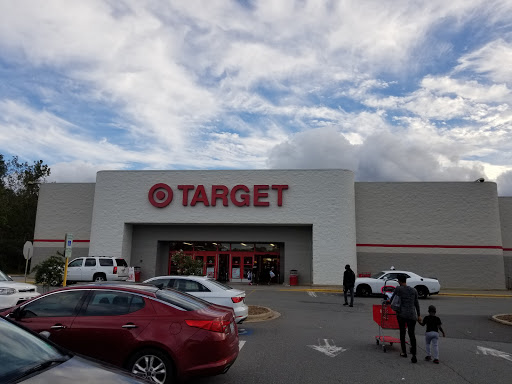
[0,316,147,384]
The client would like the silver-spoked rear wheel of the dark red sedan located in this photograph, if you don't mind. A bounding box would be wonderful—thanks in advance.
[128,349,174,384]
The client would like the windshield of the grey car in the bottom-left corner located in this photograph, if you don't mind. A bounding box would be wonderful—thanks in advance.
[0,318,71,383]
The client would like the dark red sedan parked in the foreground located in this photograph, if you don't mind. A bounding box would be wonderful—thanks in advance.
[2,284,239,383]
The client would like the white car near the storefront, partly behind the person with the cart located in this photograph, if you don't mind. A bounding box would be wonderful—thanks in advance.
[354,270,441,298]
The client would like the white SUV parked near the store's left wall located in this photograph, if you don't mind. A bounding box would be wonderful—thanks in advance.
[66,256,128,284]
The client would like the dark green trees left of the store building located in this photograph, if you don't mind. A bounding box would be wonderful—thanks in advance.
[0,154,50,273]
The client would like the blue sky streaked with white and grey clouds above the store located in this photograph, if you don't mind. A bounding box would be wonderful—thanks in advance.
[0,0,512,196]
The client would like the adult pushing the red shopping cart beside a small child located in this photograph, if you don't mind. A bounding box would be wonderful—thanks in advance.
[391,273,421,363]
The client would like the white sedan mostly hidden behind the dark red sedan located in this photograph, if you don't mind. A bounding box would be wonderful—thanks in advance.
[144,276,249,324]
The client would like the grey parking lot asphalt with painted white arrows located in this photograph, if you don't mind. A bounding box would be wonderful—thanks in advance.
[194,290,512,384]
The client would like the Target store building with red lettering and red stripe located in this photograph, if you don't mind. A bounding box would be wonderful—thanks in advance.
[32,169,512,289]
